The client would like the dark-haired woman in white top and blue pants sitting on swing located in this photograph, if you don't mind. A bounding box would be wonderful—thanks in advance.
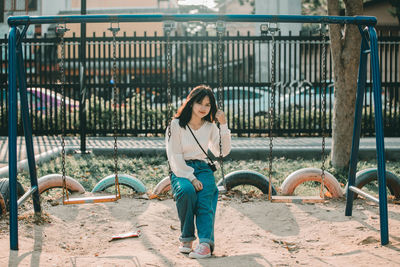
[166,85,231,258]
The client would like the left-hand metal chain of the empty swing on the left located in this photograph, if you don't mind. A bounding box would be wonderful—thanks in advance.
[56,25,69,201]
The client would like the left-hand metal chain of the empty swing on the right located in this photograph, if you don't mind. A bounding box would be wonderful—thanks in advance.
[268,25,279,200]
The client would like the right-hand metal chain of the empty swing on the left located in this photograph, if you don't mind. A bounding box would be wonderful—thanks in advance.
[109,26,121,198]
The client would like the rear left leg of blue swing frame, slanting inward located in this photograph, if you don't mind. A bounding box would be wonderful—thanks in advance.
[16,29,41,213]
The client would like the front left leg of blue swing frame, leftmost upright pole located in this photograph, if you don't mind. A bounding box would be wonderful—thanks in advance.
[8,27,18,250]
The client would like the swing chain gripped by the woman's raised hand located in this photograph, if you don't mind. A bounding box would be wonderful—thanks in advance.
[217,22,226,189]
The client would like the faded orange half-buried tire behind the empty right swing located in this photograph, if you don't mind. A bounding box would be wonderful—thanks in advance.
[281,168,343,198]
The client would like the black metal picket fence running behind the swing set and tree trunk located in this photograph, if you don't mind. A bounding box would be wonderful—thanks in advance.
[0,33,400,136]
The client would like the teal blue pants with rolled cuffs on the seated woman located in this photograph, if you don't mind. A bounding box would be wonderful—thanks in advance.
[171,160,218,250]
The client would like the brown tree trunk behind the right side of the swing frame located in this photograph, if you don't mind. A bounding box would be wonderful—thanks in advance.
[328,0,363,170]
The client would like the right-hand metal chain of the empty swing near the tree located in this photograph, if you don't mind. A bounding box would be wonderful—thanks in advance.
[320,24,326,198]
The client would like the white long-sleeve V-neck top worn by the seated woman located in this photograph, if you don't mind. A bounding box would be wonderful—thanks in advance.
[165,119,231,181]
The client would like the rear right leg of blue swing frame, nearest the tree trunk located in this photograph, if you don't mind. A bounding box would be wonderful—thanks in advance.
[345,29,369,216]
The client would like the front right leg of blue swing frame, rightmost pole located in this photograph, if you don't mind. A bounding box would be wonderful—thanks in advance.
[368,26,389,245]
